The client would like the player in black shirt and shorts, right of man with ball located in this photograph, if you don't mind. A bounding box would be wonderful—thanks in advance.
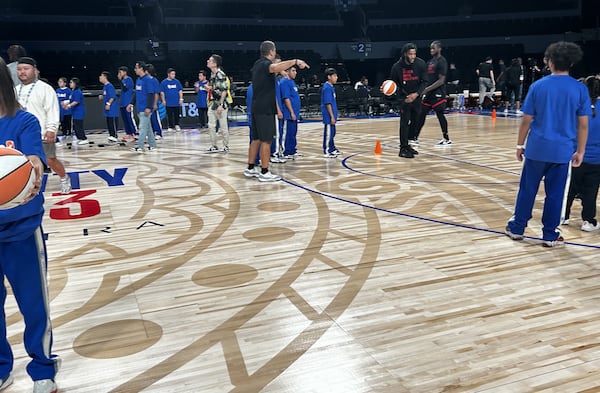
[417,41,452,146]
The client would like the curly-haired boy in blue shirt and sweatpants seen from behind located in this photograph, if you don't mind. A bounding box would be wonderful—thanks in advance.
[505,41,591,247]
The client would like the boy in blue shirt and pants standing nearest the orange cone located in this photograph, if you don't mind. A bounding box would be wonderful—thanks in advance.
[321,68,341,158]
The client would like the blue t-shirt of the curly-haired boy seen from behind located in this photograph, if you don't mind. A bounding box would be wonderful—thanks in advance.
[522,75,591,164]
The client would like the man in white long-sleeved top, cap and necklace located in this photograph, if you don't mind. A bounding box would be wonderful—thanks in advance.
[15,57,71,194]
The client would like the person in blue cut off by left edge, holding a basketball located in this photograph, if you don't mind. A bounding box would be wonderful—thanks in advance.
[0,58,60,393]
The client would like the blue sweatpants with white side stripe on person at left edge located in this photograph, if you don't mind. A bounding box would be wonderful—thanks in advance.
[0,227,57,381]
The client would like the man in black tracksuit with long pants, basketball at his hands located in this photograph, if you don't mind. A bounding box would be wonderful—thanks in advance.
[390,42,427,158]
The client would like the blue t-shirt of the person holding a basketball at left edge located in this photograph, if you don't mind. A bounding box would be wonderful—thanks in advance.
[0,110,46,242]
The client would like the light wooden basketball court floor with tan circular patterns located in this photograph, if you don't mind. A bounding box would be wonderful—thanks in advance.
[6,114,600,393]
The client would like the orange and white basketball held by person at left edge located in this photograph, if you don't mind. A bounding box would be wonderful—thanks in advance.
[0,146,35,210]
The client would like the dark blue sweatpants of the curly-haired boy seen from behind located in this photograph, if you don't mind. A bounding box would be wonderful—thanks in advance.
[508,158,570,241]
